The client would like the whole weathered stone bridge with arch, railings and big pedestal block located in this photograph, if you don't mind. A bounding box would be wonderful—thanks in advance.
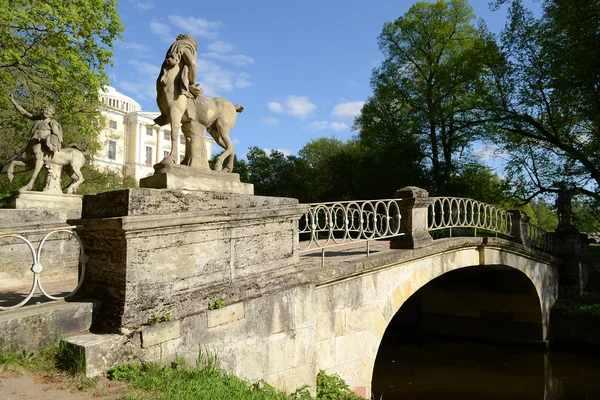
[0,188,587,396]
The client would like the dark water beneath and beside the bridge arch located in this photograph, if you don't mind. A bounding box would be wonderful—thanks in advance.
[372,340,600,400]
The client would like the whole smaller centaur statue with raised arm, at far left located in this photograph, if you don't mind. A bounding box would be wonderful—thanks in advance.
[7,95,85,193]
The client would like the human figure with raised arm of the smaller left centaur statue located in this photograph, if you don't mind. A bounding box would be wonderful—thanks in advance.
[8,94,63,190]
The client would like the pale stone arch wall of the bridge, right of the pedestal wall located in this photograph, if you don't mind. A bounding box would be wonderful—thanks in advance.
[307,238,559,393]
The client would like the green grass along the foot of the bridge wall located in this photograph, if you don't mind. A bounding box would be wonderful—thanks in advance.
[0,342,360,400]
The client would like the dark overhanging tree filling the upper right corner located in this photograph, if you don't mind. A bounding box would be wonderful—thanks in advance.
[486,0,600,201]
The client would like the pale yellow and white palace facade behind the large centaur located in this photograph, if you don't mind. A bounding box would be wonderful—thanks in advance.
[93,86,214,179]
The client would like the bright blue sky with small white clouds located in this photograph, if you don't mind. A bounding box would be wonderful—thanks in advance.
[108,0,536,156]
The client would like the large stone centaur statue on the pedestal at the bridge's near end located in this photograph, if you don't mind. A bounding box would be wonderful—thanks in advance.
[154,35,244,172]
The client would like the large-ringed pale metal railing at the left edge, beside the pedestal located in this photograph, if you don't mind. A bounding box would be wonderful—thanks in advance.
[0,226,88,310]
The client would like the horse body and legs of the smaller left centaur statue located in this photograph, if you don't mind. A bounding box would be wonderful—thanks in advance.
[6,145,85,194]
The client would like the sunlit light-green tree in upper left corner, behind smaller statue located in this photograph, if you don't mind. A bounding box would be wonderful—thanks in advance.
[0,0,123,164]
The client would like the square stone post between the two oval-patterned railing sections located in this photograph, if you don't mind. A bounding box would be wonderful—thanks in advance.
[390,186,433,249]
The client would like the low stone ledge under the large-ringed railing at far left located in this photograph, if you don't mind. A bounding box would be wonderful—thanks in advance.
[0,300,94,350]
